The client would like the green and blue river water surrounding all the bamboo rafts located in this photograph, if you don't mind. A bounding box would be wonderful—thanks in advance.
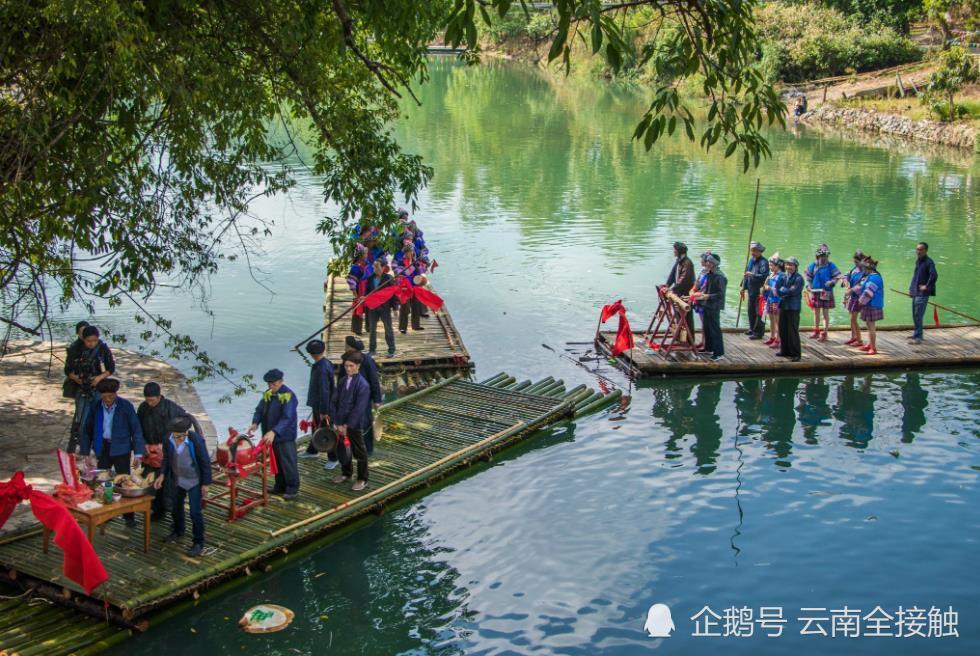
[90,61,980,656]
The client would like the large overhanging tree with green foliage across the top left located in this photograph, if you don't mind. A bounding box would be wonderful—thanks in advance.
[0,0,785,390]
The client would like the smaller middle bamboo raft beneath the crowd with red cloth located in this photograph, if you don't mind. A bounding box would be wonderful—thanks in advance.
[323,275,473,373]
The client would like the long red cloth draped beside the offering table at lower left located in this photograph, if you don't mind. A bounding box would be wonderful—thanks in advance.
[0,471,109,594]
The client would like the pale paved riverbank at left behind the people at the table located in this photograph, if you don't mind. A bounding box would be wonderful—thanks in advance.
[0,341,217,532]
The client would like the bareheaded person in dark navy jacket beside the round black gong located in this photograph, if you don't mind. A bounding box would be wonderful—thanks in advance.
[331,351,371,492]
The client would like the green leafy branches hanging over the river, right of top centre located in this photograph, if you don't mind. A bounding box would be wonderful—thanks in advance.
[446,0,786,170]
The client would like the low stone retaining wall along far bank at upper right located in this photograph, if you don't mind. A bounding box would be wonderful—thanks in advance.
[802,105,980,150]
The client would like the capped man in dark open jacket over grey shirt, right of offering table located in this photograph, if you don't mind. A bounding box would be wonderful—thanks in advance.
[153,416,211,557]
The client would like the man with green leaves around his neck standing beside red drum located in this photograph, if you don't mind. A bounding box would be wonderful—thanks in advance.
[248,369,299,501]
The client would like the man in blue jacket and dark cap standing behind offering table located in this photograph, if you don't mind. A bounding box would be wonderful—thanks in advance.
[79,378,145,528]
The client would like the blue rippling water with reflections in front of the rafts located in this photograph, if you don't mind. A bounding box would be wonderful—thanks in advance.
[124,368,980,656]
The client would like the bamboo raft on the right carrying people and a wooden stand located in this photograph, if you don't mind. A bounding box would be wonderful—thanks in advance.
[596,324,980,377]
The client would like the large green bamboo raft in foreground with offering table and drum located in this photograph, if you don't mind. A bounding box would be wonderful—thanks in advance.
[0,374,620,654]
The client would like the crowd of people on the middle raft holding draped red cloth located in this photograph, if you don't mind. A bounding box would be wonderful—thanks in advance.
[347,209,438,357]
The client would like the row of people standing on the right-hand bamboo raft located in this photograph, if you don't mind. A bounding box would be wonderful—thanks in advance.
[666,241,938,362]
